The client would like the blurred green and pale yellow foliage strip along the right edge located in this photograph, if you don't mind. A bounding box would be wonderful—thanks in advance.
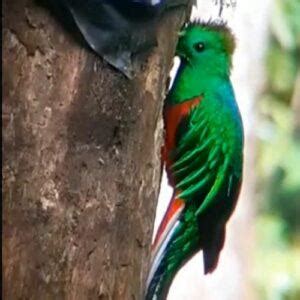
[253,0,300,300]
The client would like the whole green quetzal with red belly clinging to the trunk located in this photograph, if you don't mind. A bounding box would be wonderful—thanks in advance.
[145,21,243,300]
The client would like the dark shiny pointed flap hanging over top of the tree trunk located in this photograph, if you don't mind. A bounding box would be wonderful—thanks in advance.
[48,0,195,78]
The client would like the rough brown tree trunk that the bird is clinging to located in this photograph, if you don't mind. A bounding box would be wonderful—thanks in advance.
[2,0,189,300]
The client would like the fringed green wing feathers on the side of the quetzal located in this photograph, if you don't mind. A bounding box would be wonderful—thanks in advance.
[171,107,240,215]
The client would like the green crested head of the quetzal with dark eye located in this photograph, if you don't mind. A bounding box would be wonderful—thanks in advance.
[176,21,235,74]
